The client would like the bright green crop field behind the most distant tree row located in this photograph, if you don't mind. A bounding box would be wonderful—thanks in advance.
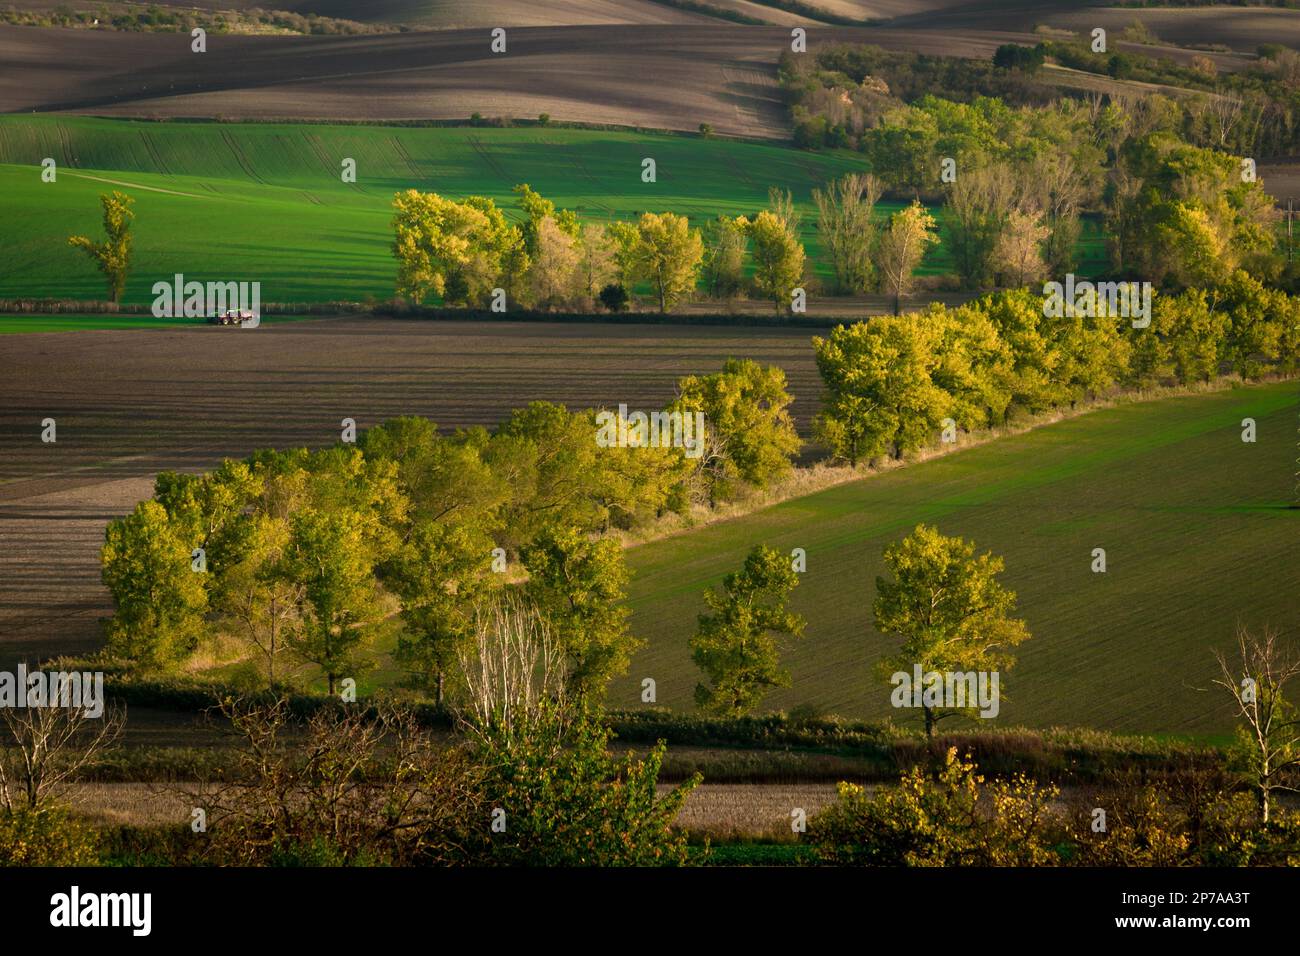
[0,116,1101,303]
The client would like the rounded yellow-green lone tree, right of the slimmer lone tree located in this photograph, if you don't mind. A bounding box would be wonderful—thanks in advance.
[872,524,1030,736]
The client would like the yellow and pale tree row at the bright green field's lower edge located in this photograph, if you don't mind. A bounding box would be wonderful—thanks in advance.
[393,179,961,312]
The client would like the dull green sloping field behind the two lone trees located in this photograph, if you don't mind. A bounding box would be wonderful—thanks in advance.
[611,382,1300,732]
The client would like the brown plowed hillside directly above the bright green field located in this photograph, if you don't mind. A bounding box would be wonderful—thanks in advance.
[0,25,1032,138]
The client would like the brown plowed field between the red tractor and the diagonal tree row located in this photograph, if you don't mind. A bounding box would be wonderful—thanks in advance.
[0,319,820,666]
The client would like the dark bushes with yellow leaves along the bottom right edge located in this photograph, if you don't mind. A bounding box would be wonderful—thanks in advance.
[809,748,1300,868]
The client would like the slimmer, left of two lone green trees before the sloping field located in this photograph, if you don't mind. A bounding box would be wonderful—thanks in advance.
[690,545,803,717]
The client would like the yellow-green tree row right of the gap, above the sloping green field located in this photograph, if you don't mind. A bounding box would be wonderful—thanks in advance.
[813,272,1300,464]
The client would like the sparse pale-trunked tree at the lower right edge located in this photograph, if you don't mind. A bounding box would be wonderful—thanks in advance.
[1214,627,1300,823]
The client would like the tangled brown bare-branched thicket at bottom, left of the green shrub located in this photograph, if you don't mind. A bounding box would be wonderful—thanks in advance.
[181,698,486,865]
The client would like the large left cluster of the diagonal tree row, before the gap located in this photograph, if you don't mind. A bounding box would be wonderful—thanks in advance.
[103,360,801,701]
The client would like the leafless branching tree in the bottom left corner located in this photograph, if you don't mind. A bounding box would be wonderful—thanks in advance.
[0,706,124,812]
